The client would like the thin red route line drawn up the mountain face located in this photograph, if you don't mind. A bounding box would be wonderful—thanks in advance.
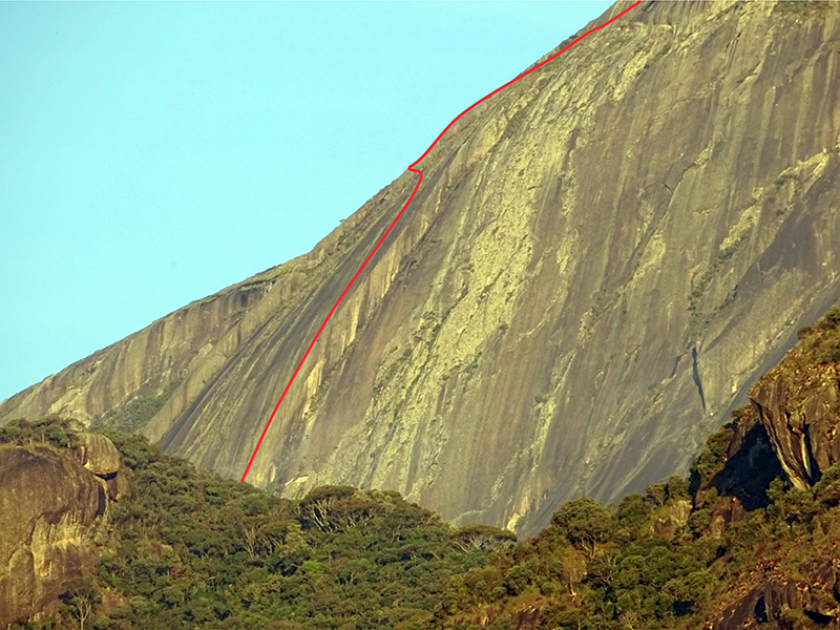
[240,0,642,482]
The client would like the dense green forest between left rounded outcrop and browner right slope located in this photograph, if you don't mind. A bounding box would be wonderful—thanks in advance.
[0,419,506,629]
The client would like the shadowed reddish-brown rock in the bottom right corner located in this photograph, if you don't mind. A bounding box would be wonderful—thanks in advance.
[708,559,840,630]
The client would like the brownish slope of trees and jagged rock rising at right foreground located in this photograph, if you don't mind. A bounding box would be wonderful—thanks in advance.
[444,306,840,630]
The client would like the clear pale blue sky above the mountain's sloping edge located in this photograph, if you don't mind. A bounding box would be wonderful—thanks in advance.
[0,2,610,399]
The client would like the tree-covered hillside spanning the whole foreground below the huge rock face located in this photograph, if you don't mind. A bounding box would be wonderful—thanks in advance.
[8,308,840,630]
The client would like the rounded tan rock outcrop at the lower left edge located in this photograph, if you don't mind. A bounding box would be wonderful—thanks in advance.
[0,446,108,627]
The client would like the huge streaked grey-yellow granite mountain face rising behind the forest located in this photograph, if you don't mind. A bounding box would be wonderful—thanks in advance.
[0,2,840,534]
